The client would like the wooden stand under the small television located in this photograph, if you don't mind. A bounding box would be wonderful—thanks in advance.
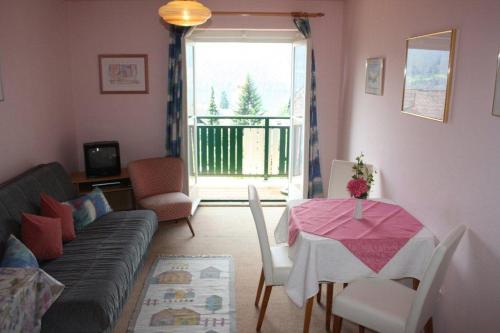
[71,168,135,210]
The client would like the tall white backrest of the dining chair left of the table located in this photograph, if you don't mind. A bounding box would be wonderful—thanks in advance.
[248,185,273,285]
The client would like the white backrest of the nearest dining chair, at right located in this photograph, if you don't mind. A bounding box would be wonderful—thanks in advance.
[405,224,467,333]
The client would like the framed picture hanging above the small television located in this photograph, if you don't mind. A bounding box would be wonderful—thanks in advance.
[99,54,149,94]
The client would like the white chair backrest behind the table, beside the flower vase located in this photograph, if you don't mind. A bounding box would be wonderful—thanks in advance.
[328,160,373,199]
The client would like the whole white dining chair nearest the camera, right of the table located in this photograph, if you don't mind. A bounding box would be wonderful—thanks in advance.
[333,225,466,333]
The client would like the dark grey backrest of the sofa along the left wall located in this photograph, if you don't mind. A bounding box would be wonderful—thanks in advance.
[0,162,75,258]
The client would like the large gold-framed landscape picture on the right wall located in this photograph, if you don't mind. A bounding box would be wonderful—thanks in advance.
[401,30,456,122]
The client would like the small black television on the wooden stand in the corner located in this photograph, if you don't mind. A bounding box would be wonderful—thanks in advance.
[83,141,121,178]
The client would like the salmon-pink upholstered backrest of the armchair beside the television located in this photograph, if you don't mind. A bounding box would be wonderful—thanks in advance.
[128,157,184,200]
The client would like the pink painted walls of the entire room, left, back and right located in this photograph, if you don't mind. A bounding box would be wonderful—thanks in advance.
[0,0,500,332]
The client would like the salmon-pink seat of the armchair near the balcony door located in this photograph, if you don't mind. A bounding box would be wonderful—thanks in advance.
[139,192,192,221]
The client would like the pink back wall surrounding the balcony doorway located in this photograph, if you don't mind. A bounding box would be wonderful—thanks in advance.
[68,0,343,189]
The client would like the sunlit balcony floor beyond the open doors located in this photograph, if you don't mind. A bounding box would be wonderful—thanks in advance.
[198,177,288,201]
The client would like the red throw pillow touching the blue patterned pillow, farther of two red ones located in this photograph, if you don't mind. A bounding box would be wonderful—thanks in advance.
[40,193,76,242]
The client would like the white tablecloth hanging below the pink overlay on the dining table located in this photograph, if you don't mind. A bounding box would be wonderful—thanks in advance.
[274,200,436,306]
